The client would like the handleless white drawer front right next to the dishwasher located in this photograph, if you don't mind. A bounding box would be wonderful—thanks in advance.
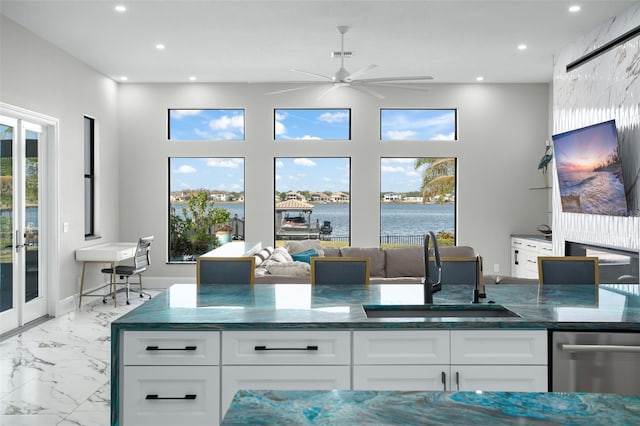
[451,330,547,365]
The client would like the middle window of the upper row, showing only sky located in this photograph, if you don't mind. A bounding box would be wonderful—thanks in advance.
[273,109,351,141]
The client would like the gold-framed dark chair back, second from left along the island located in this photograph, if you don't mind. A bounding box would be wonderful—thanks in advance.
[311,257,369,285]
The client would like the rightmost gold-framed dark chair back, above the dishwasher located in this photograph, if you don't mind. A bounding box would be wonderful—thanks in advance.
[538,256,600,285]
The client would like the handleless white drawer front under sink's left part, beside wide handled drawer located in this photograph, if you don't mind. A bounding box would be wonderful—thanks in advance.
[353,330,449,365]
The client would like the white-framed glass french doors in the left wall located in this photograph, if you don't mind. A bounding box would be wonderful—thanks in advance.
[0,116,47,333]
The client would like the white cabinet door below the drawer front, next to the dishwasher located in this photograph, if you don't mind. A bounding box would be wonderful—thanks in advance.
[450,365,548,392]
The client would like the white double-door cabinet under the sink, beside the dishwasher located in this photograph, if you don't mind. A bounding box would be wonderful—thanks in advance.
[353,330,547,392]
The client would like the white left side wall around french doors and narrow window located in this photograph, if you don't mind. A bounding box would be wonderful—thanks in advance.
[0,16,119,306]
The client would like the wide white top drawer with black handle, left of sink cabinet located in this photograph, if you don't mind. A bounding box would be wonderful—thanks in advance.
[222,331,351,365]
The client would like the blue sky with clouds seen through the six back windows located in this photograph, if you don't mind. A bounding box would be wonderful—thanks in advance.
[169,109,455,192]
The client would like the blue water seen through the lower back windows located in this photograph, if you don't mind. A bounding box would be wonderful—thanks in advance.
[170,203,455,237]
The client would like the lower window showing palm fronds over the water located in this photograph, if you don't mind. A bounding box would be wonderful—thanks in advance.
[380,157,456,247]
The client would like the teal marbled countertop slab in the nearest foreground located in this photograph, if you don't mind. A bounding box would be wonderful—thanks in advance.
[222,390,640,426]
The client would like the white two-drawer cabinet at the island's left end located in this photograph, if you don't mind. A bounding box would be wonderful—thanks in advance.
[120,331,220,426]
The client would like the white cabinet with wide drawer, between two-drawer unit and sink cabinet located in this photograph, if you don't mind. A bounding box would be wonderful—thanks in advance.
[222,331,351,415]
